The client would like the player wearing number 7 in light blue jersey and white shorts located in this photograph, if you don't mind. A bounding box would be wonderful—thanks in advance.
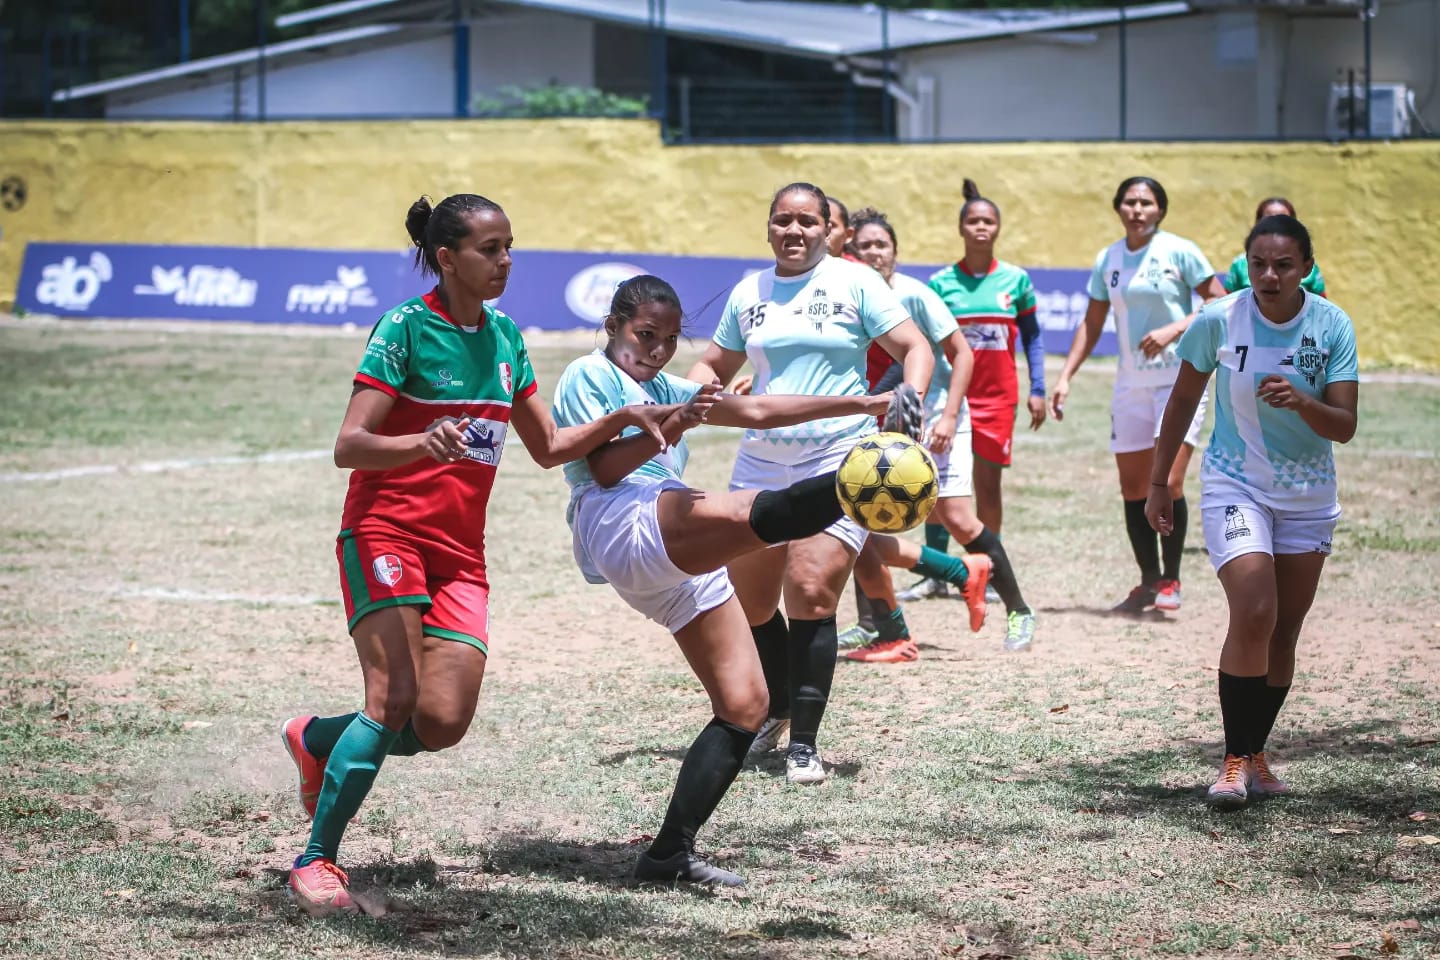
[1145,214,1359,809]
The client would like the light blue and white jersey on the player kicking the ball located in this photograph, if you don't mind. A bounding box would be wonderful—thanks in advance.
[553,350,700,491]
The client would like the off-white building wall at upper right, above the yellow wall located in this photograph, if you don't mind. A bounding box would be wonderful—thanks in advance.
[900,0,1440,140]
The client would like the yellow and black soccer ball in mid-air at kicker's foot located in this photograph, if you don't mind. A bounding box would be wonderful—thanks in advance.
[835,433,940,534]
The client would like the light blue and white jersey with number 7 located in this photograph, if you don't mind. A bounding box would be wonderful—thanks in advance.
[1179,289,1359,511]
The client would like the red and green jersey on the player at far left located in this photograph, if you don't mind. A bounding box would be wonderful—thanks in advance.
[341,284,536,577]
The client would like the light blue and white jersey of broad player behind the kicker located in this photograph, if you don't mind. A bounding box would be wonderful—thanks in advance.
[714,256,909,465]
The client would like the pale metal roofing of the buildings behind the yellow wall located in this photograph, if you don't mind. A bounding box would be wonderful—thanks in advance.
[52,0,1191,101]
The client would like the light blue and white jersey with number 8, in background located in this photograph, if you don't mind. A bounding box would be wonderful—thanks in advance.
[1090,230,1215,389]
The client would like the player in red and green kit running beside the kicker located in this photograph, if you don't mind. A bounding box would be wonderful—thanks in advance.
[282,193,674,915]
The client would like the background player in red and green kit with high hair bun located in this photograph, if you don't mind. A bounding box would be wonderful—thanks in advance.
[930,178,1045,535]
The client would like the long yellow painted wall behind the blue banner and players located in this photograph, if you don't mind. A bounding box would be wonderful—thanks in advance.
[0,121,1440,368]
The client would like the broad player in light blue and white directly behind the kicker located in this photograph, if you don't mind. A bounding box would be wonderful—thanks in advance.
[690,183,935,783]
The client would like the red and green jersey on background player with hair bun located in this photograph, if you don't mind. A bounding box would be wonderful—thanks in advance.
[930,261,1035,406]
